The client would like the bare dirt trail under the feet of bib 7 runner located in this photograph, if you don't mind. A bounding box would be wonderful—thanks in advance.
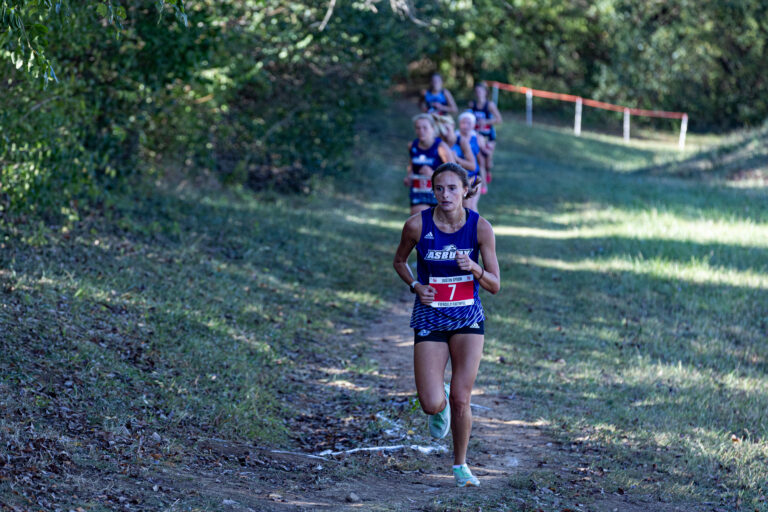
[226,294,685,512]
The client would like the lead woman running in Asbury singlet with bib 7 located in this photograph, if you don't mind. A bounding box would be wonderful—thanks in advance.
[394,163,500,487]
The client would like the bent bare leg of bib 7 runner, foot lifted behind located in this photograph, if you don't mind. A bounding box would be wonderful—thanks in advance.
[413,341,449,414]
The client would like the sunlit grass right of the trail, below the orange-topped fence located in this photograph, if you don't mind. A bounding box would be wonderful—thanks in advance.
[480,119,768,511]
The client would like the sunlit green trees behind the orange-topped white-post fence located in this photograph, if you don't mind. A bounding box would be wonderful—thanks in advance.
[428,0,768,130]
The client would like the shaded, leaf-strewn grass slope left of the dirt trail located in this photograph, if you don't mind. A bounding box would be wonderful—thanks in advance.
[0,149,402,510]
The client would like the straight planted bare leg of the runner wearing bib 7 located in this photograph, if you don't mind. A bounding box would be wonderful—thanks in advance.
[449,334,485,465]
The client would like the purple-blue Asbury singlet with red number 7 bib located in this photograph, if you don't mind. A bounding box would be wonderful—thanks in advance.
[411,208,485,331]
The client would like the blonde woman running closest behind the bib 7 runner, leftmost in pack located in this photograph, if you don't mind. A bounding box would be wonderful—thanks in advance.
[403,114,454,215]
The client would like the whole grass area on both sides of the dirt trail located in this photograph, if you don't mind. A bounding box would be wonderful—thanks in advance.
[0,106,768,511]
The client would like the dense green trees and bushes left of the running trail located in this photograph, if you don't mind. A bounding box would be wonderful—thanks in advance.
[0,0,421,218]
